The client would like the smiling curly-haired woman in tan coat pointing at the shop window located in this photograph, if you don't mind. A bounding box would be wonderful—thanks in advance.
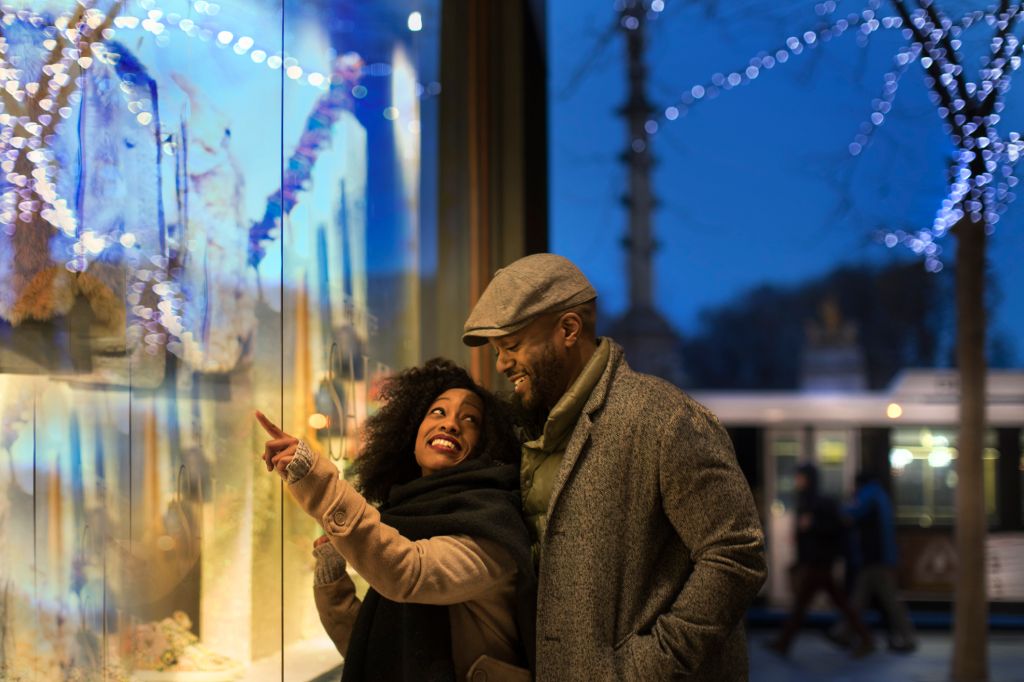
[256,359,537,681]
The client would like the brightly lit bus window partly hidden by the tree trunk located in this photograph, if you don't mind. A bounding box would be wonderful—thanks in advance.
[889,427,999,527]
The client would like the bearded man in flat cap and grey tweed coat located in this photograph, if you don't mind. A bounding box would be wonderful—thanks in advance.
[463,254,765,682]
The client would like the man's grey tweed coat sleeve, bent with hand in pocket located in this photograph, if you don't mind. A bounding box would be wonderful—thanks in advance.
[621,403,766,679]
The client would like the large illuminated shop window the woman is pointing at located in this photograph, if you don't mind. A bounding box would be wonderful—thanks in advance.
[0,0,440,680]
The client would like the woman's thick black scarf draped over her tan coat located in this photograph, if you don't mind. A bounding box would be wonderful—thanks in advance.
[341,460,537,682]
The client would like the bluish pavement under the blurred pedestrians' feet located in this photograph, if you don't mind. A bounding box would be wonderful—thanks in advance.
[748,628,1024,682]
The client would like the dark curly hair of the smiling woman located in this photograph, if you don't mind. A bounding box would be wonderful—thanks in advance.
[353,357,519,503]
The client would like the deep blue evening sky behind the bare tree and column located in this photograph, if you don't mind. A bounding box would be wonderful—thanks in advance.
[548,0,1024,367]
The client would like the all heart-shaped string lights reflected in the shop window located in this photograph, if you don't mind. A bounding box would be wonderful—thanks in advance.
[0,0,380,353]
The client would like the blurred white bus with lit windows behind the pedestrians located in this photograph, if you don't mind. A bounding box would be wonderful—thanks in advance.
[691,369,1024,612]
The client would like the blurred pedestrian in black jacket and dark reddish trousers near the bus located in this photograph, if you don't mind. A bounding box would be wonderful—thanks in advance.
[768,464,874,657]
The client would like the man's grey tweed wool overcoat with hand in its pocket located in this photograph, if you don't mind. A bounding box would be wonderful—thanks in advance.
[537,338,765,682]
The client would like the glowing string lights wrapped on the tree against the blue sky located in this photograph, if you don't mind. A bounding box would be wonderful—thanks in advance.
[647,0,1024,272]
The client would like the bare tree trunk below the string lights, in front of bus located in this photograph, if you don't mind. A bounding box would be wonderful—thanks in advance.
[952,215,988,682]
